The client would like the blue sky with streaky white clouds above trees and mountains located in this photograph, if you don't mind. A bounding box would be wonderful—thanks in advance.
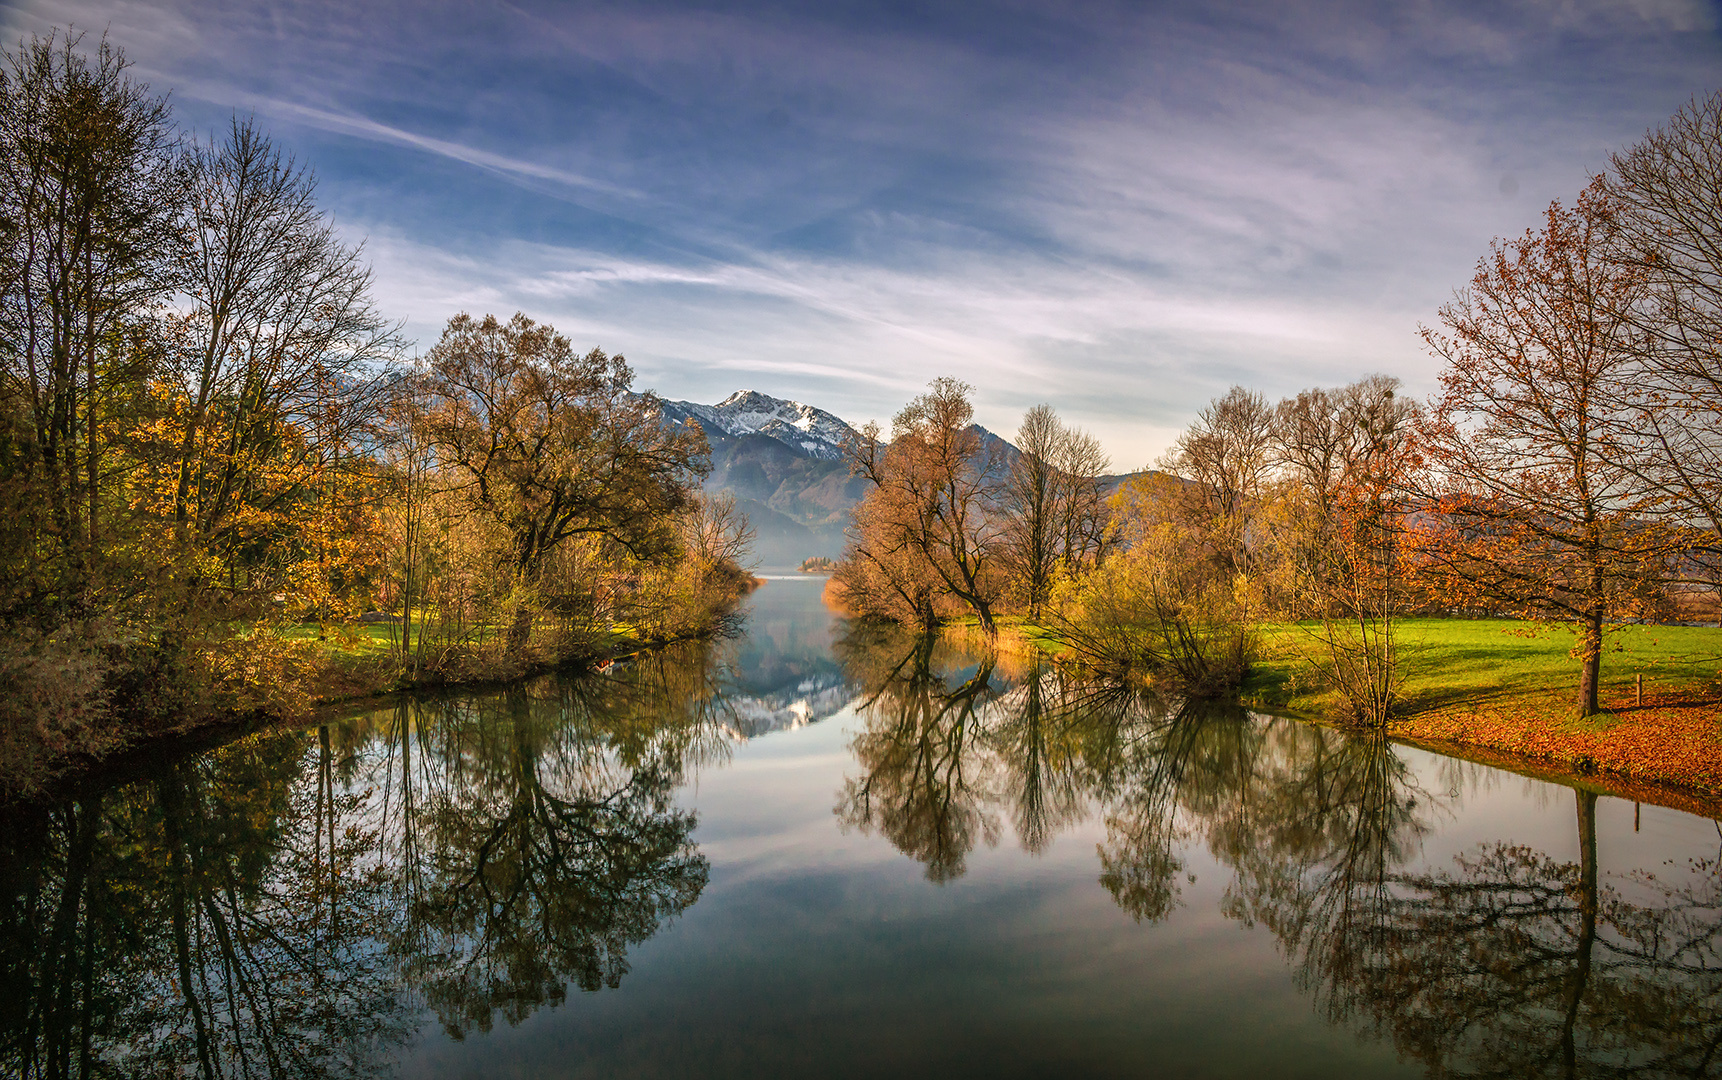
[10,0,1722,469]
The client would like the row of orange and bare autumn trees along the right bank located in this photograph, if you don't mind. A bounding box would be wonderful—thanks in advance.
[839,93,1722,722]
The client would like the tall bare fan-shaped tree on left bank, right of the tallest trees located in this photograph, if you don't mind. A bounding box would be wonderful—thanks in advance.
[162,119,400,616]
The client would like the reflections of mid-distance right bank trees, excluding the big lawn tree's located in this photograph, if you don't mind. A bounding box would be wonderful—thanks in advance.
[837,627,1440,922]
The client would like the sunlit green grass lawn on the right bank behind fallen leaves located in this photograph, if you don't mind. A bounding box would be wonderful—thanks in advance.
[1245,618,1722,711]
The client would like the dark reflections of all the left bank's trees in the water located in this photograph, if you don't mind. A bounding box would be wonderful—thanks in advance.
[0,655,723,1078]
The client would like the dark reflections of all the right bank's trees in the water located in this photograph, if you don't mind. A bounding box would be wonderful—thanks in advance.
[837,629,1722,1078]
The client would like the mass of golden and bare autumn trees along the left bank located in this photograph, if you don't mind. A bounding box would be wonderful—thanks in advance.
[0,33,747,787]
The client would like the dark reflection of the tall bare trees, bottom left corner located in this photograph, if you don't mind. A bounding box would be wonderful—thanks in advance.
[0,732,406,1077]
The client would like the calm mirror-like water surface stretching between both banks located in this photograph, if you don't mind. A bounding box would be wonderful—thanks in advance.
[0,575,1722,1077]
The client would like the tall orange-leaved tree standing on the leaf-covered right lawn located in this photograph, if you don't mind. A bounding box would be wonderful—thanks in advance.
[1419,183,1677,717]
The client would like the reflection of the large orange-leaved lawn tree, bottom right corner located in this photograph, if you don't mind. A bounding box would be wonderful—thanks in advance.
[1316,791,1722,1077]
